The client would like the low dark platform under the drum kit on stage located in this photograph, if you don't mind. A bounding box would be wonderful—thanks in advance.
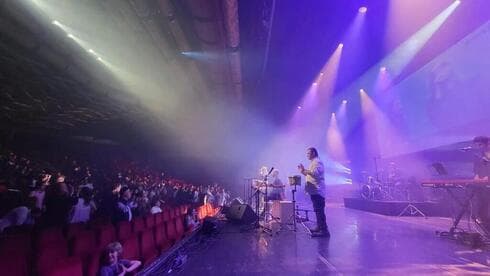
[344,197,451,217]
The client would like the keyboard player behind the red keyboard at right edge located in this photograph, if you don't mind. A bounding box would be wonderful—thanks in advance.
[473,136,490,231]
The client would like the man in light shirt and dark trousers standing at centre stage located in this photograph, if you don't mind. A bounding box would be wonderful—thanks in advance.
[298,148,330,237]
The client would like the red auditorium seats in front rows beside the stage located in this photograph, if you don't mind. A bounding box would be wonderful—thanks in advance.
[0,205,203,275]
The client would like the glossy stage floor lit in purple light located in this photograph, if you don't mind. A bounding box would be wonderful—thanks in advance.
[168,205,490,275]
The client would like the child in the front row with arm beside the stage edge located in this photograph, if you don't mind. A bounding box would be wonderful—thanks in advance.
[99,242,141,276]
